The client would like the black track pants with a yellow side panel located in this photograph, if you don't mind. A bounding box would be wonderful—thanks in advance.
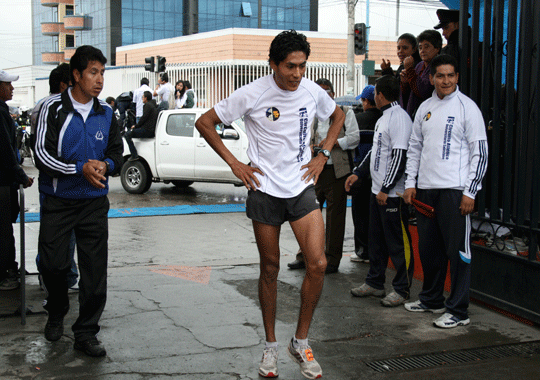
[366,193,414,298]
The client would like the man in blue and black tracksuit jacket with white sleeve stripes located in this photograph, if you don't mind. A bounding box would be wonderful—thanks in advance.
[35,45,123,356]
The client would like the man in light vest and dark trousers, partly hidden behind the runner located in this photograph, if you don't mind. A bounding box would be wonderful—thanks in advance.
[287,78,360,274]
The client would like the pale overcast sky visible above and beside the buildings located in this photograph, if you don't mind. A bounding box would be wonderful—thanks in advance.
[0,0,445,69]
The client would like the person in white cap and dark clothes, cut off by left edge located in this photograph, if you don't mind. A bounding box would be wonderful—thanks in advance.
[0,70,34,290]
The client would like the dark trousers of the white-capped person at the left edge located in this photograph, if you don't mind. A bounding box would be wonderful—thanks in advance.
[0,186,19,280]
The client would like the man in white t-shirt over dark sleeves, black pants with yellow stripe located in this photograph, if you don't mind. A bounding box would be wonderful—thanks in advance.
[345,75,414,307]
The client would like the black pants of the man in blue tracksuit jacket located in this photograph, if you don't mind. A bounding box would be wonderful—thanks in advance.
[38,195,109,340]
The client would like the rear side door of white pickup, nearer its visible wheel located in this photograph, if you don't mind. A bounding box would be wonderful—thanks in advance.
[156,113,196,179]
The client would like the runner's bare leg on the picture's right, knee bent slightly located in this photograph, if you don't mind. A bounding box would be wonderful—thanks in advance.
[291,210,326,339]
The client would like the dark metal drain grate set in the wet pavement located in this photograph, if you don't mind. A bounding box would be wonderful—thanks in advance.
[366,341,540,372]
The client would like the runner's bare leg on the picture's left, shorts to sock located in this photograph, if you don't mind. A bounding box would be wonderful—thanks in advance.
[253,221,281,342]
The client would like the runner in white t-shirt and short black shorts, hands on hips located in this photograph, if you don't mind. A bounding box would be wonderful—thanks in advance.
[195,30,345,379]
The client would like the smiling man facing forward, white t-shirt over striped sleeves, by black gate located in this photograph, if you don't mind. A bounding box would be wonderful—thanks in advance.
[404,54,488,328]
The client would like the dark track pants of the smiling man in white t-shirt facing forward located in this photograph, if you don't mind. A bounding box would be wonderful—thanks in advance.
[416,189,471,319]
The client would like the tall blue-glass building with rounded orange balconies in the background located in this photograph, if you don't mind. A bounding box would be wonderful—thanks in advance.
[32,0,318,65]
